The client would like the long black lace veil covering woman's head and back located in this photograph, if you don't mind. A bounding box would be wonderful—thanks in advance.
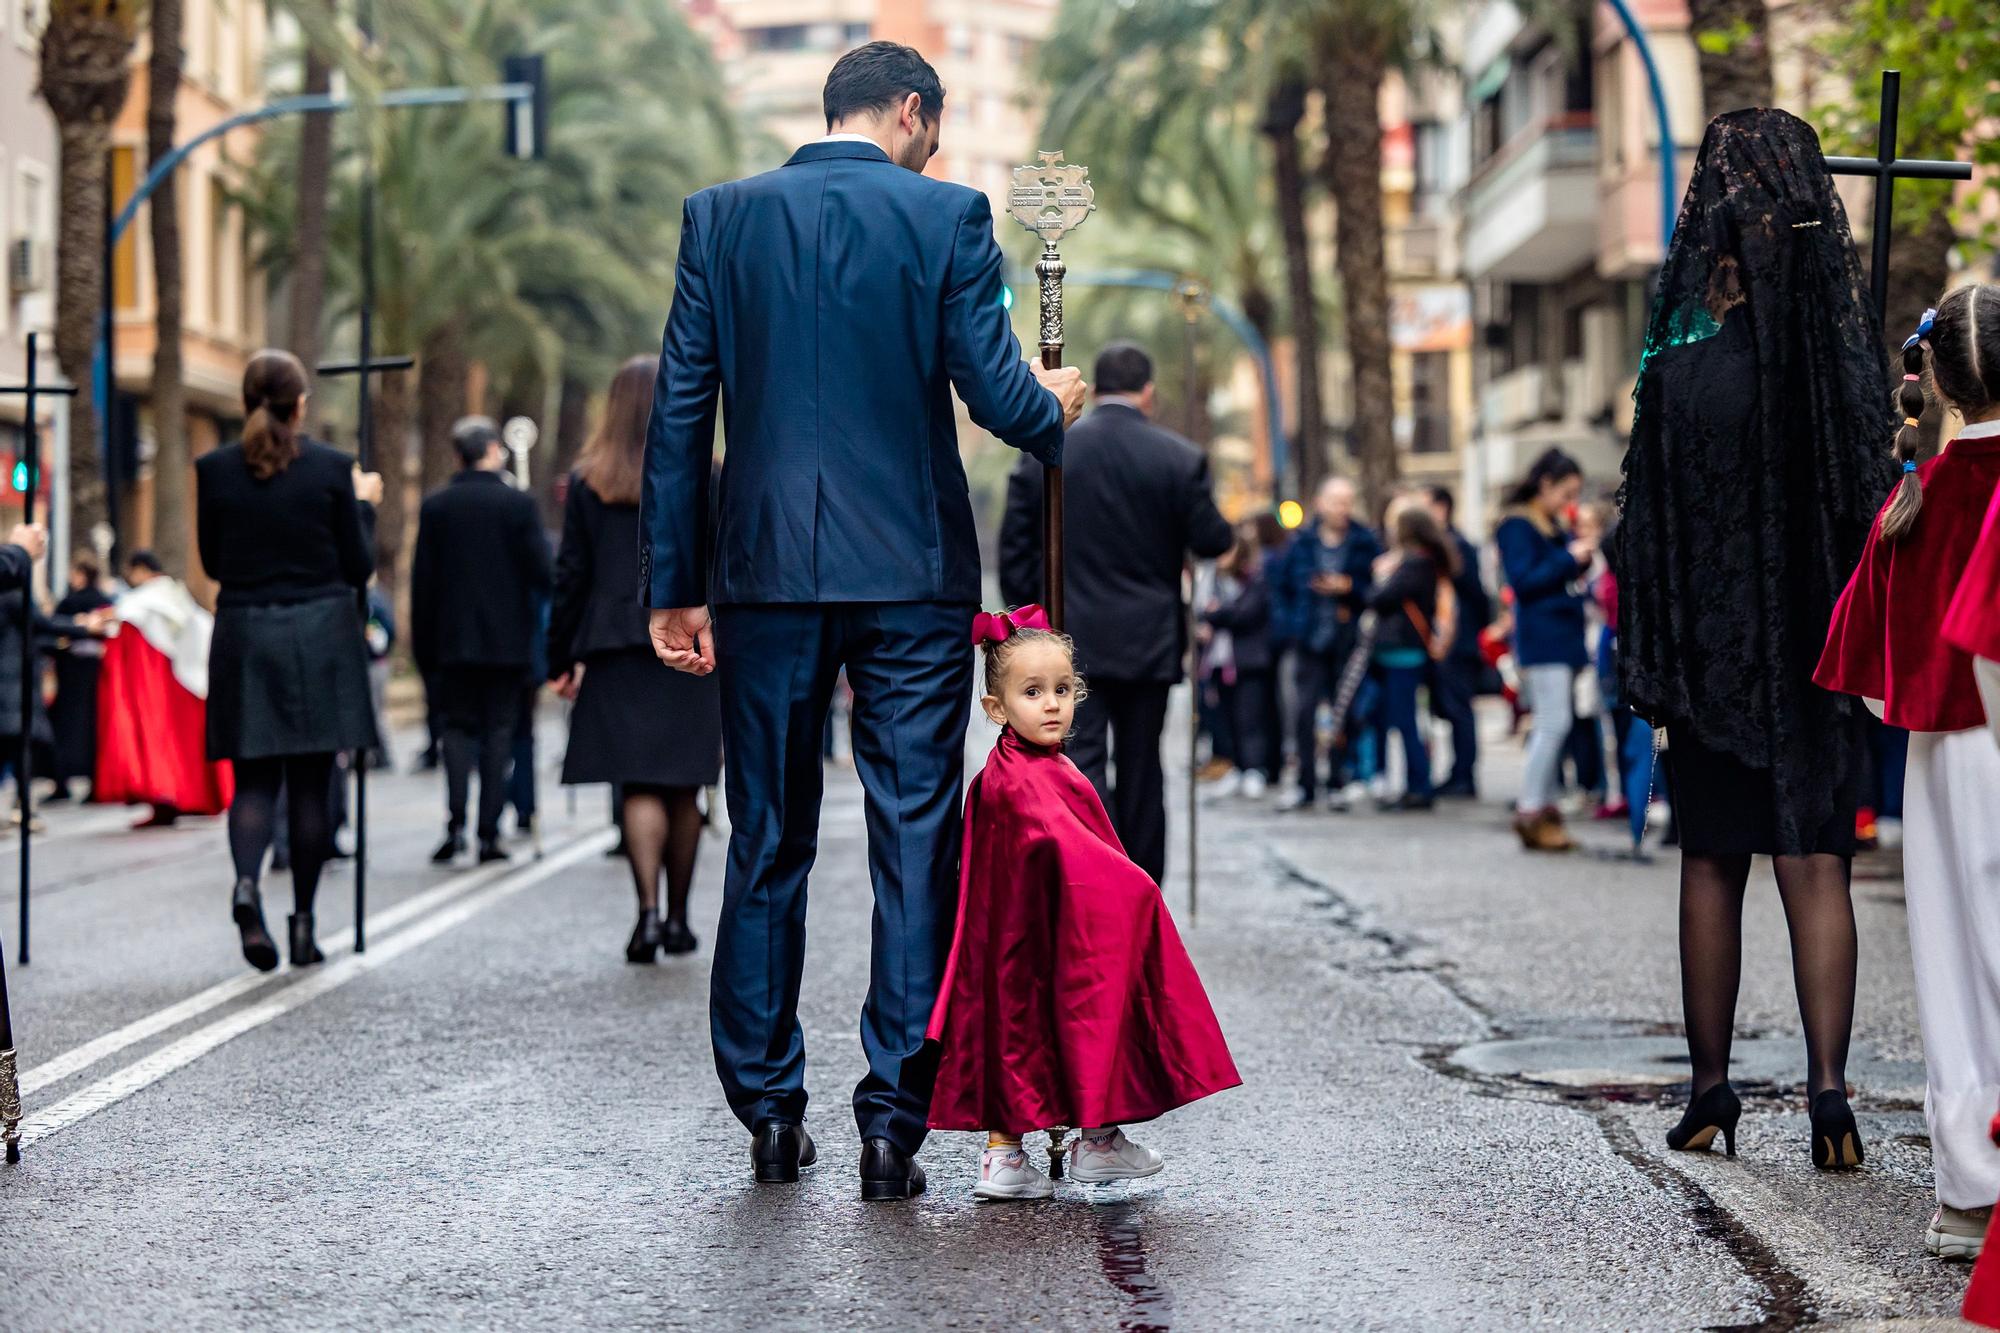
[1614,110,1894,847]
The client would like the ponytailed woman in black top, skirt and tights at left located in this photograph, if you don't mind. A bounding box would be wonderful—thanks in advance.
[194,352,382,973]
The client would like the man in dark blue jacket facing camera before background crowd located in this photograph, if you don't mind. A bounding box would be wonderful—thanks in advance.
[1274,476,1382,811]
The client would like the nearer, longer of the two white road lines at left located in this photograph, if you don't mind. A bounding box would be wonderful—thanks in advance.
[22,829,612,1143]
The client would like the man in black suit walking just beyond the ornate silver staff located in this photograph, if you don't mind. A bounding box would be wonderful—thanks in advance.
[1000,342,1234,883]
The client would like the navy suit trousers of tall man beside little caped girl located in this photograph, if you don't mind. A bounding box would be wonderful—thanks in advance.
[710,602,974,1153]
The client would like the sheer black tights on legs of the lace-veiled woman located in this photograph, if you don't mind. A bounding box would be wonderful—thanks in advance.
[1680,853,1856,1097]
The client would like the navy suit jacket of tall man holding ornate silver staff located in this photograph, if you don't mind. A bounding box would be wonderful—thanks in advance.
[640,142,1062,606]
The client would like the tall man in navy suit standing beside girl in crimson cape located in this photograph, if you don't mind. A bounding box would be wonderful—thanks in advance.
[640,42,1084,1199]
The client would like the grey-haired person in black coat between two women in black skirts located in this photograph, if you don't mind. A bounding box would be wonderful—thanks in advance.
[410,416,552,865]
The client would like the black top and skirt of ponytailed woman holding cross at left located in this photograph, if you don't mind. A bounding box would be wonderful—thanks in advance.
[194,440,376,759]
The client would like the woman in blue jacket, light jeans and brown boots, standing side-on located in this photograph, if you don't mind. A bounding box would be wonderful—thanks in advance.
[1494,448,1596,851]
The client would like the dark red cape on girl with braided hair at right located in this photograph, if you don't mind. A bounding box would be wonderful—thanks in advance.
[1812,436,2000,731]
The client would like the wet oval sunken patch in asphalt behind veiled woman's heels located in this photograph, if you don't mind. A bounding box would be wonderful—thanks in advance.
[1446,1037,1924,1103]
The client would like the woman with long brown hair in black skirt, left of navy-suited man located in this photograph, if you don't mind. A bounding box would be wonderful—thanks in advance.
[548,356,722,963]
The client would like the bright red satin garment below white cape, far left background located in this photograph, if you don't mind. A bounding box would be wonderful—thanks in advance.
[90,626,236,815]
